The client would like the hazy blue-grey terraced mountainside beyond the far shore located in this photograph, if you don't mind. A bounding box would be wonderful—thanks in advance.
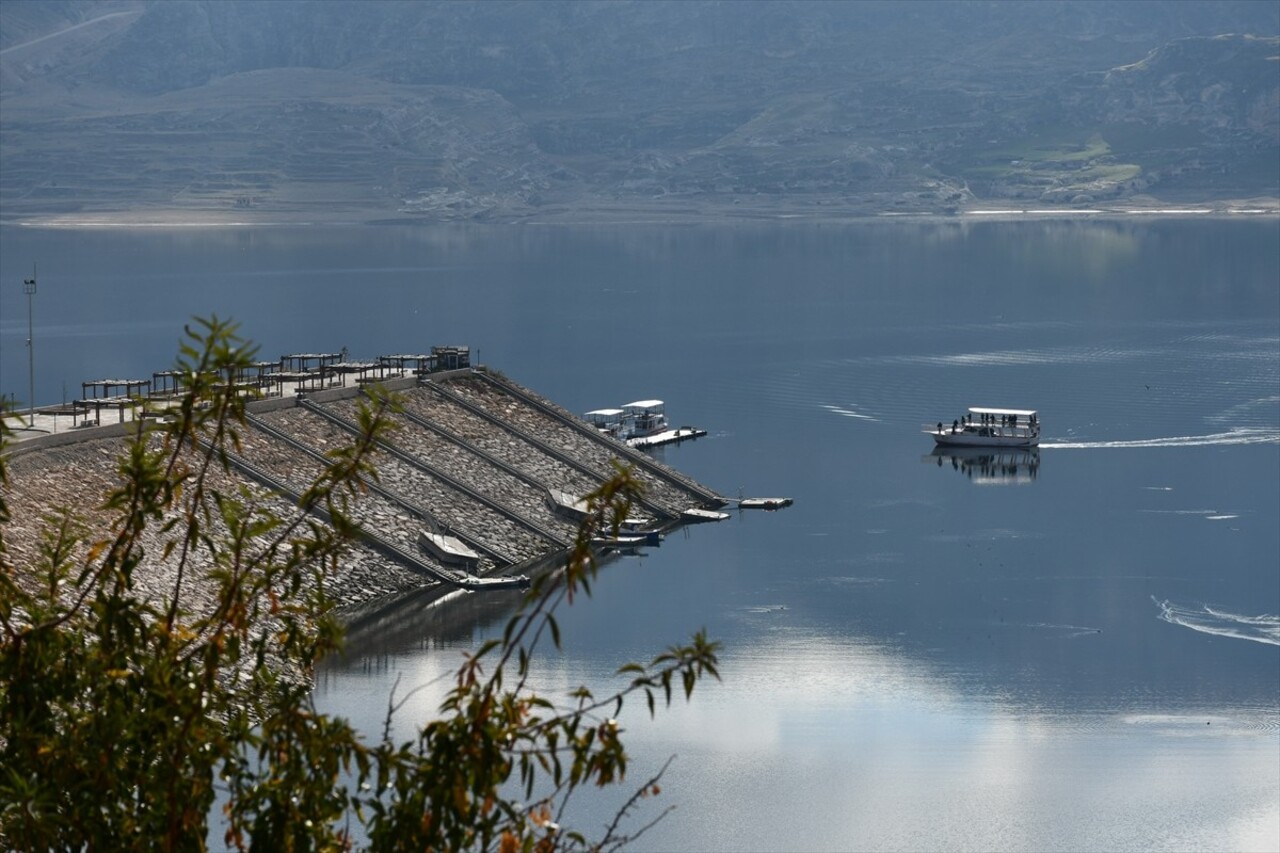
[0,0,1280,220]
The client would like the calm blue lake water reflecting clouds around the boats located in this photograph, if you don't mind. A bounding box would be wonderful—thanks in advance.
[0,219,1280,850]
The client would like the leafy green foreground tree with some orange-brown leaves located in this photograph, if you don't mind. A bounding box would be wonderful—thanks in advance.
[0,318,717,852]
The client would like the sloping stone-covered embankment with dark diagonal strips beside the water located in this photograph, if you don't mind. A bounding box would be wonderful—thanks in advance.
[8,366,728,616]
